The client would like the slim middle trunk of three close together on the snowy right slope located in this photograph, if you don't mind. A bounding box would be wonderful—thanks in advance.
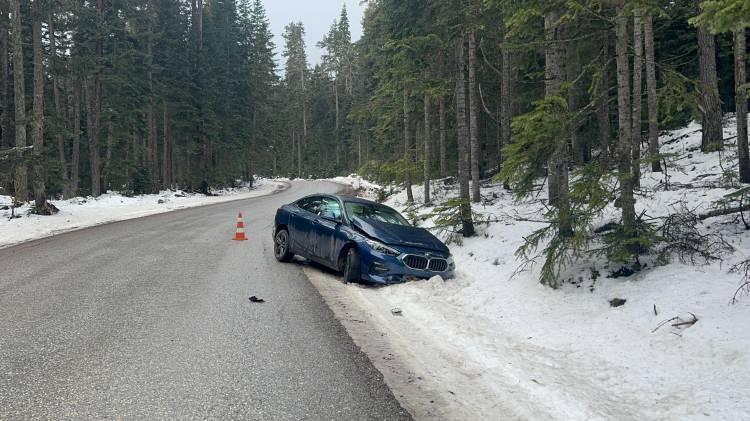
[630,8,643,189]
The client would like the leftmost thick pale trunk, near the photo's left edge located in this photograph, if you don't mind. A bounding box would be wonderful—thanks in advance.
[10,0,29,203]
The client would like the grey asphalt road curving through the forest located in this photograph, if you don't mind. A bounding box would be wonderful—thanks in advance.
[0,182,409,420]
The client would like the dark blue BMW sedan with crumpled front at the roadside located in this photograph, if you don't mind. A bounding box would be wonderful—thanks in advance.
[273,194,455,284]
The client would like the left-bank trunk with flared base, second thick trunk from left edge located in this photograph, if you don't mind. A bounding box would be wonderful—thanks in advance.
[31,0,48,215]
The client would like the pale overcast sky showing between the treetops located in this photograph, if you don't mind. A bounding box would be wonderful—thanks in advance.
[263,0,365,67]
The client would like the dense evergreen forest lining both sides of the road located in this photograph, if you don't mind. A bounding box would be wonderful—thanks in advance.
[0,0,750,285]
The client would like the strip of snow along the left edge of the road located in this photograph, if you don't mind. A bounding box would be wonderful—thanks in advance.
[0,178,285,248]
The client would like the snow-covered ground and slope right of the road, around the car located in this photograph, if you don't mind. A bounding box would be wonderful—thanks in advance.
[326,116,750,420]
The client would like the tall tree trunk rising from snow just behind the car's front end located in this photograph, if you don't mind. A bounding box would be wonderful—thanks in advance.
[455,38,474,237]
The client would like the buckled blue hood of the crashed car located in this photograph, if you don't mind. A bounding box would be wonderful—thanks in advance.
[352,217,449,254]
